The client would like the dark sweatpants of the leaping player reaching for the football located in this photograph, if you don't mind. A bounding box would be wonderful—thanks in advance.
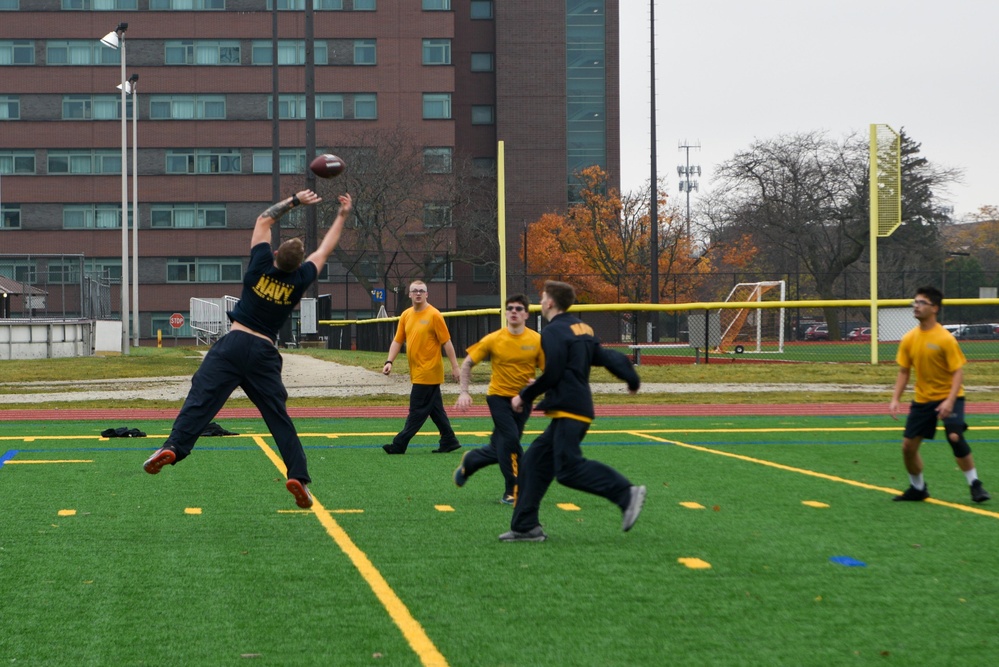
[166,331,312,484]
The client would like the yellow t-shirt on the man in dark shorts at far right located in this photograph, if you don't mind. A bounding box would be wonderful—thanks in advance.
[895,324,968,403]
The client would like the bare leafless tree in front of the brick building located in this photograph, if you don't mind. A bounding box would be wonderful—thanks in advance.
[298,127,498,312]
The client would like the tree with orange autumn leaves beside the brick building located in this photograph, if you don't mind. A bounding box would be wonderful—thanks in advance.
[521,167,736,303]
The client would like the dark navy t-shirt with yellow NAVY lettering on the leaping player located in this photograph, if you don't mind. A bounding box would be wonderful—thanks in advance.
[227,243,317,340]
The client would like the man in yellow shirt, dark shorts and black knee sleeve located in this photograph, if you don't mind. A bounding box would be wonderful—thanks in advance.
[888,287,992,503]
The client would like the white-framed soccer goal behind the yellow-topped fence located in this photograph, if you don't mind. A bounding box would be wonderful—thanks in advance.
[716,280,786,354]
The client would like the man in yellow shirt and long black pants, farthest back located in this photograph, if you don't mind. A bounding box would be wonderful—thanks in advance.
[382,280,461,454]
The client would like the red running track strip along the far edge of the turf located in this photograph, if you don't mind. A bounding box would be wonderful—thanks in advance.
[7,402,999,422]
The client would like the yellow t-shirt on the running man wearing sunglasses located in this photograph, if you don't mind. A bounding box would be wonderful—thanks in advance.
[468,327,545,396]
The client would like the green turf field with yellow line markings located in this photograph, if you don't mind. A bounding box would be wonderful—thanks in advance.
[0,416,999,667]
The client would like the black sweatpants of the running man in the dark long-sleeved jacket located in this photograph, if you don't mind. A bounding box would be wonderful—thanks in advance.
[510,417,631,533]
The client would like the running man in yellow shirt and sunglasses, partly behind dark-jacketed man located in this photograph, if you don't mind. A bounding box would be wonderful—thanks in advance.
[454,294,545,505]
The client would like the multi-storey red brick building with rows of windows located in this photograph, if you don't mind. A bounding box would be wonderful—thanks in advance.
[0,0,620,339]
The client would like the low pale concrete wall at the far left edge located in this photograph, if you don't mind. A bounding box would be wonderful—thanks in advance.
[0,320,94,360]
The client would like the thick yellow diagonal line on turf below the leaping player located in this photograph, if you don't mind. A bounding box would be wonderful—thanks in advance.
[253,435,447,667]
